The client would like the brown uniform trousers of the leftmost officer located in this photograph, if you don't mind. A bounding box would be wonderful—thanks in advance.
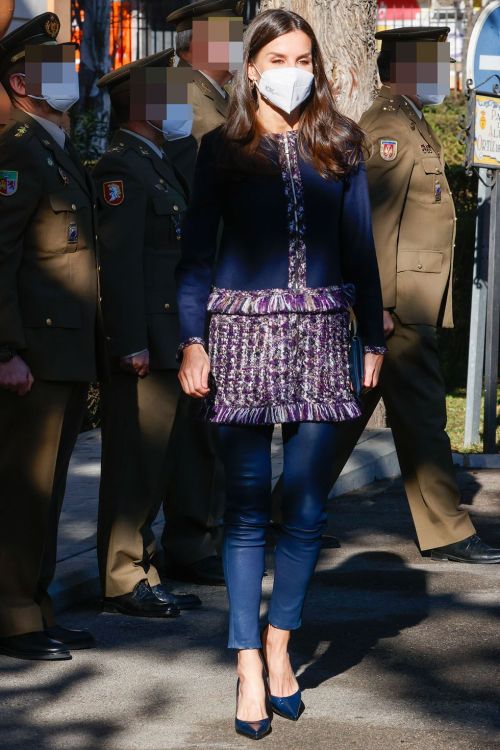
[0,380,88,637]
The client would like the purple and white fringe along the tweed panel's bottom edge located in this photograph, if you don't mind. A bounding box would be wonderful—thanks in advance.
[206,400,362,425]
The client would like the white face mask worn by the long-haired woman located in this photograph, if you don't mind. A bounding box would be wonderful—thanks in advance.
[254,65,314,114]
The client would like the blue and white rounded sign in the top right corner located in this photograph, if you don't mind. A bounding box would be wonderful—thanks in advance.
[466,0,500,94]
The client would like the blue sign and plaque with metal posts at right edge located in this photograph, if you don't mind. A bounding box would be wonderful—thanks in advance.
[464,0,500,453]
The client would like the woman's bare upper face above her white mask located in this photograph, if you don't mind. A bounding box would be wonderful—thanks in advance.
[248,30,313,81]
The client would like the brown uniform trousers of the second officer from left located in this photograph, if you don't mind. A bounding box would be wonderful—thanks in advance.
[97,368,180,597]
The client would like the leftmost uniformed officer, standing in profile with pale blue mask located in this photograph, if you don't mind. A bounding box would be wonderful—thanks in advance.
[0,13,104,660]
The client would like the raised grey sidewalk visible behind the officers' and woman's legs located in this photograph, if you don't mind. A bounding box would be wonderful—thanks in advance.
[51,429,399,611]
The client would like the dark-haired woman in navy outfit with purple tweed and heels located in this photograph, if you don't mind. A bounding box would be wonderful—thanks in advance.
[178,10,385,739]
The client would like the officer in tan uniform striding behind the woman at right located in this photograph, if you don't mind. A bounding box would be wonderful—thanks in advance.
[335,27,500,563]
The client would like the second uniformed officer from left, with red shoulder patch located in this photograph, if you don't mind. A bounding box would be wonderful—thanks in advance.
[93,50,202,617]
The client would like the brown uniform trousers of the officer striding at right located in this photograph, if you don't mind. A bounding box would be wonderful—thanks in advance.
[334,315,475,550]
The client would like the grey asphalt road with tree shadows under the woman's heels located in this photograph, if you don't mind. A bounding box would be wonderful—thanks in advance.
[0,470,500,750]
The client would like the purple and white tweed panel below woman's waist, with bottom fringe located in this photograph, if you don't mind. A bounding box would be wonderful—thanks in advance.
[205,294,361,425]
